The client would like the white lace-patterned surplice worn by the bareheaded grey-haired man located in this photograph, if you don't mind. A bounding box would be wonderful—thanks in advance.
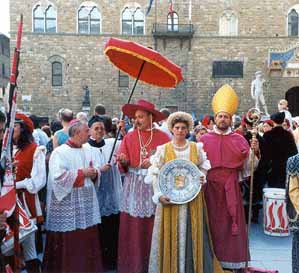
[46,144,101,232]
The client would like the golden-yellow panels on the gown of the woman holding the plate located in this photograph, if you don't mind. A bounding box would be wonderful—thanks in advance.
[158,142,224,273]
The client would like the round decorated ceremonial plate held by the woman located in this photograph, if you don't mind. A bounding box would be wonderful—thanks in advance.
[158,159,204,204]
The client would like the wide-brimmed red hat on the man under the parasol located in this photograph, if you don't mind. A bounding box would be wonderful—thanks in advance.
[122,100,167,122]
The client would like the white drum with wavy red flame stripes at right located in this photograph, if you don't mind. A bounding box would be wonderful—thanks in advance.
[263,188,290,237]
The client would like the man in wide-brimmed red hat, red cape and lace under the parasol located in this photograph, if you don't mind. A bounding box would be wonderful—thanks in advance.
[117,100,170,273]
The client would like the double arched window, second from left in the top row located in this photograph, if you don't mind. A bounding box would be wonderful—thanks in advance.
[78,5,101,34]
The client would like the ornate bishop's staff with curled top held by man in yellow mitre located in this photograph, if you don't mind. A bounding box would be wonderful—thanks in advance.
[245,108,261,272]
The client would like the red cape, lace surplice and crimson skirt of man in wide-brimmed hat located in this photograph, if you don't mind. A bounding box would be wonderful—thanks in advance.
[117,129,169,273]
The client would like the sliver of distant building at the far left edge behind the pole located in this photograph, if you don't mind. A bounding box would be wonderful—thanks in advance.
[0,33,10,90]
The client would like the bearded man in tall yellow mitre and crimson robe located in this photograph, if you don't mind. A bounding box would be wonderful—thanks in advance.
[200,85,258,270]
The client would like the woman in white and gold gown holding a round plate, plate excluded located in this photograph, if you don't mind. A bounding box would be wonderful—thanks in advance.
[146,112,223,273]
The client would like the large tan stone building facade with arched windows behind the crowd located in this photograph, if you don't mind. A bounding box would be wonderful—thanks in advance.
[10,0,299,116]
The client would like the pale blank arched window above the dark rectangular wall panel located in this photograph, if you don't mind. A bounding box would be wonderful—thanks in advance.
[219,10,238,36]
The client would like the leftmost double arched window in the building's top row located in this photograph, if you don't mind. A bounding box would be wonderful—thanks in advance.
[33,4,57,32]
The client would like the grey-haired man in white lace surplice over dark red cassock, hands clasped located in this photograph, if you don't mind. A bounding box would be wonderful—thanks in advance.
[43,120,103,272]
